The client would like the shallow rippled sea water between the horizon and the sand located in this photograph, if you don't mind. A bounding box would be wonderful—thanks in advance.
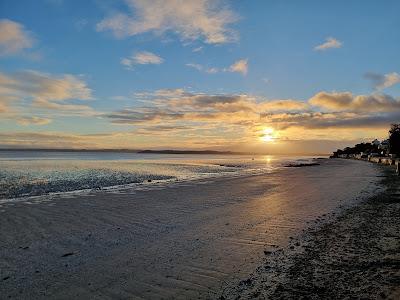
[0,151,318,199]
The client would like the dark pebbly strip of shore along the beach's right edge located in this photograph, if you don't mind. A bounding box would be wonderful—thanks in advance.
[220,166,400,299]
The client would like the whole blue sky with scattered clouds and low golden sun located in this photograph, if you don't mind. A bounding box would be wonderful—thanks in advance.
[0,0,400,154]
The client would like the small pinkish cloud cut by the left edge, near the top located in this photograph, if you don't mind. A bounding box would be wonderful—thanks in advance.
[0,19,34,56]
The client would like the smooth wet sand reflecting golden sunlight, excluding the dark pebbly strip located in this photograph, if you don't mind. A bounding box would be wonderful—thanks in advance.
[0,160,382,299]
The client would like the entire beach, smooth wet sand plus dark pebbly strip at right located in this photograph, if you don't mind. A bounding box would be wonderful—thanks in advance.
[0,159,399,299]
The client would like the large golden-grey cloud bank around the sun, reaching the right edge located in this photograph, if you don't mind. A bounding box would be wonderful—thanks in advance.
[103,89,400,145]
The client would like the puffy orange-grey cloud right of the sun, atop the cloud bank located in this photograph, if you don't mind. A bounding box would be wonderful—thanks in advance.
[309,92,400,112]
